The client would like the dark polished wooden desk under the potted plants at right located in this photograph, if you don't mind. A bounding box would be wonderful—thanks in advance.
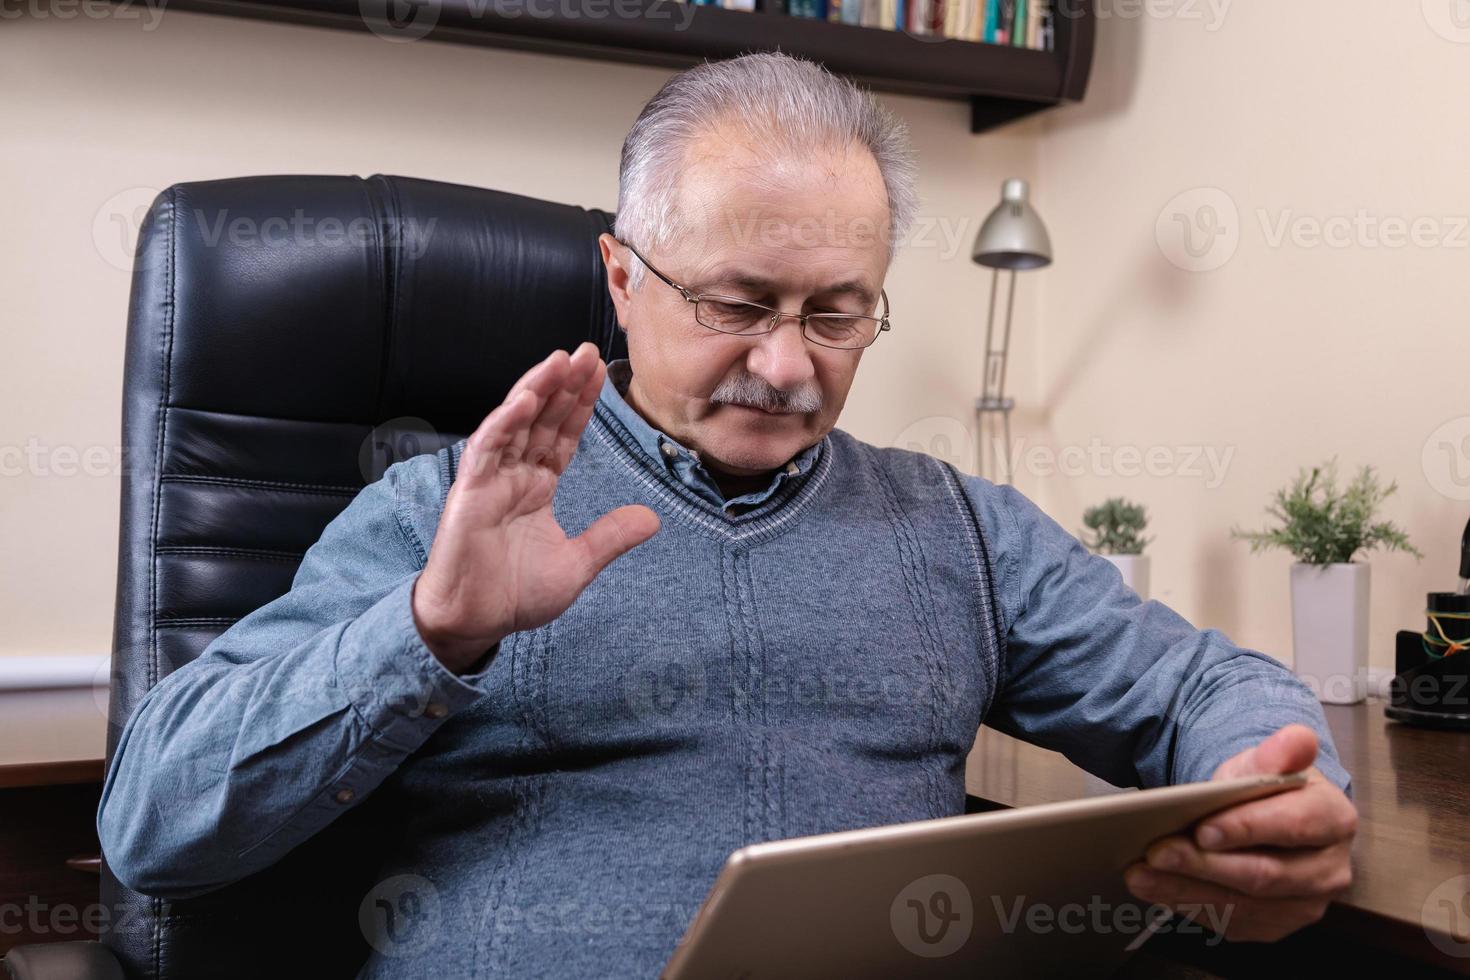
[966,701,1470,977]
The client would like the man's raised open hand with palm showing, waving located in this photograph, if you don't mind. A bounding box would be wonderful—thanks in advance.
[413,344,659,671]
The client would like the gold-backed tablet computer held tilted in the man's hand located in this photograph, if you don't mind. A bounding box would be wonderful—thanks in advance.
[662,773,1307,980]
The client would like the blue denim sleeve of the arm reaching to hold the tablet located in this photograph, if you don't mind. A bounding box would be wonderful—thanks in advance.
[966,476,1352,796]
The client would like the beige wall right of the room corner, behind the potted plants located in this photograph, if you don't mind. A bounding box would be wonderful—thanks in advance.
[1028,0,1470,669]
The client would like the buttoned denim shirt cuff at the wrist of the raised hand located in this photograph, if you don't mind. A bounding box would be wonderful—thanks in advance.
[337,572,498,751]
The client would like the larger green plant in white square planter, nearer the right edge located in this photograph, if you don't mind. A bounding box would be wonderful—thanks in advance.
[1230,458,1423,704]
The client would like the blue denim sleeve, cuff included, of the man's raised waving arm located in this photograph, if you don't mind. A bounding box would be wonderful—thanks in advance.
[97,455,495,898]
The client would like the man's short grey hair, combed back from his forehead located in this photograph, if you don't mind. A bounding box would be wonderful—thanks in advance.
[613,51,919,288]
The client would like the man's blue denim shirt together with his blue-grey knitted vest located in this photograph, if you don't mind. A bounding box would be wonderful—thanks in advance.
[97,370,1351,980]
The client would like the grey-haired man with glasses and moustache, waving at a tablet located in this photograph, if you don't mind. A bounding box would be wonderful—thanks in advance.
[98,54,1355,979]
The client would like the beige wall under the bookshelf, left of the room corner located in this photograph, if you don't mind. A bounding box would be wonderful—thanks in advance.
[0,6,1036,655]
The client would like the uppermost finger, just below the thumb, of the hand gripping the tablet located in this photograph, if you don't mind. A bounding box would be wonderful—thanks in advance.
[1194,777,1358,851]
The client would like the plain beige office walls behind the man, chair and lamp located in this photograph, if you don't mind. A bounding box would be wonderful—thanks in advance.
[0,0,1470,667]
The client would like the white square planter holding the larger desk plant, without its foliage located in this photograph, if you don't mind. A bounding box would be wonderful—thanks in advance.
[1291,561,1369,704]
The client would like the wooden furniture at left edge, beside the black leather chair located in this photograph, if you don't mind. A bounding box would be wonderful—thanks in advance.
[0,688,107,954]
